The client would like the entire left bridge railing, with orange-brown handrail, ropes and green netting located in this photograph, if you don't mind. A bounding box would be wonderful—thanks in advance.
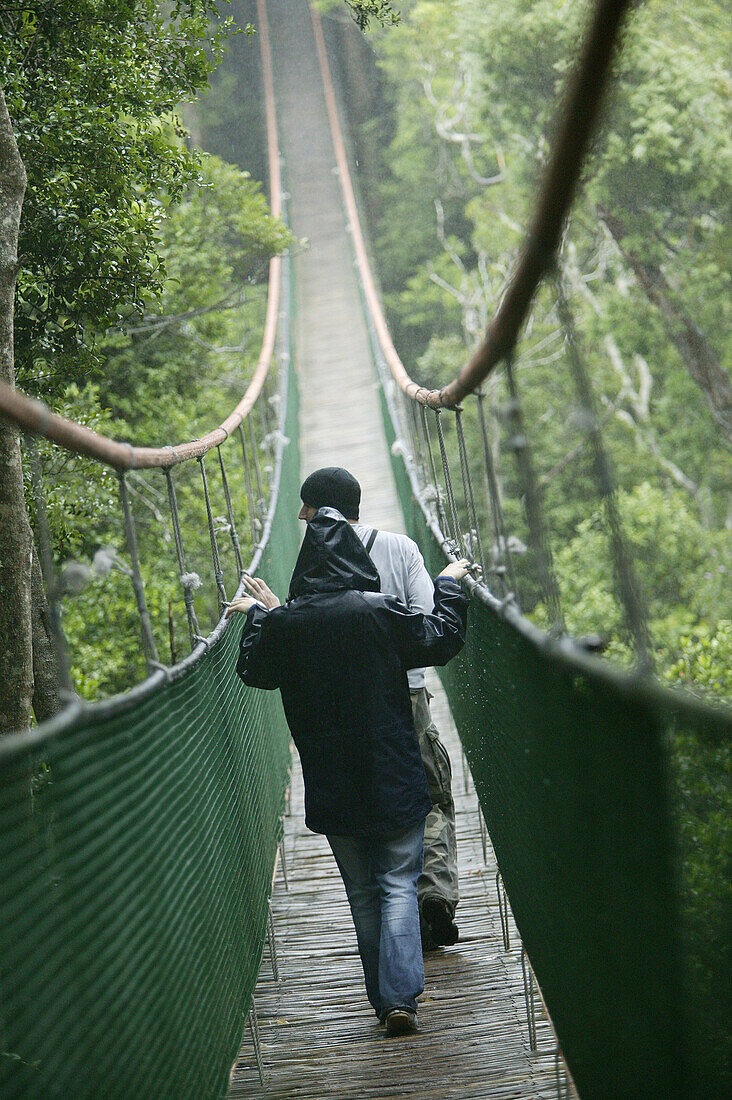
[0,4,299,1100]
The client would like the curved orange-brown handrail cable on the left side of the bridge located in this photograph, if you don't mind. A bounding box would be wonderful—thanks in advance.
[0,0,282,471]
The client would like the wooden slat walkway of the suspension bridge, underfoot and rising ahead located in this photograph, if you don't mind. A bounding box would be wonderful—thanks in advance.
[229,0,555,1100]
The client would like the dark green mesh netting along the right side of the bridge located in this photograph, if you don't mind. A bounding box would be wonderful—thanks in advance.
[382,371,732,1100]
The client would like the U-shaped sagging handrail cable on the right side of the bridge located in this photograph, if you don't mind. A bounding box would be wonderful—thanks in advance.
[310,0,631,408]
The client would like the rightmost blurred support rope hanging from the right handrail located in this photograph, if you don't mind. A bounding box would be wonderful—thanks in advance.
[554,270,653,674]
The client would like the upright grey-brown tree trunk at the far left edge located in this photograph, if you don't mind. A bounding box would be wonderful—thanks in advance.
[0,89,33,734]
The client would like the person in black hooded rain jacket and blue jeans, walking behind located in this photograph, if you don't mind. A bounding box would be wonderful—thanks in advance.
[230,508,468,1034]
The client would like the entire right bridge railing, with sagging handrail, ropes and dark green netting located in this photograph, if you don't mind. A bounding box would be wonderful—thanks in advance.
[314,2,732,1100]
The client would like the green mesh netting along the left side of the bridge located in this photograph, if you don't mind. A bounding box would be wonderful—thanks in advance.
[0,345,299,1100]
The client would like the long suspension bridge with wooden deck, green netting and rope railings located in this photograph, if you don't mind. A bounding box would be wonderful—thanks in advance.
[0,0,732,1100]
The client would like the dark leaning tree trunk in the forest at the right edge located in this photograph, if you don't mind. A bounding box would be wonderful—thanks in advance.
[598,209,732,447]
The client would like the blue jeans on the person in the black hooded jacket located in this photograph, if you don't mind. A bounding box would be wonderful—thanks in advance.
[328,822,425,1018]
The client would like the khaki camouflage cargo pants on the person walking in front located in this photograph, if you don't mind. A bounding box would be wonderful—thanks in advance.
[412,688,459,915]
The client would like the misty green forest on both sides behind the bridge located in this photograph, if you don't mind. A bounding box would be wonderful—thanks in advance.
[0,0,732,700]
